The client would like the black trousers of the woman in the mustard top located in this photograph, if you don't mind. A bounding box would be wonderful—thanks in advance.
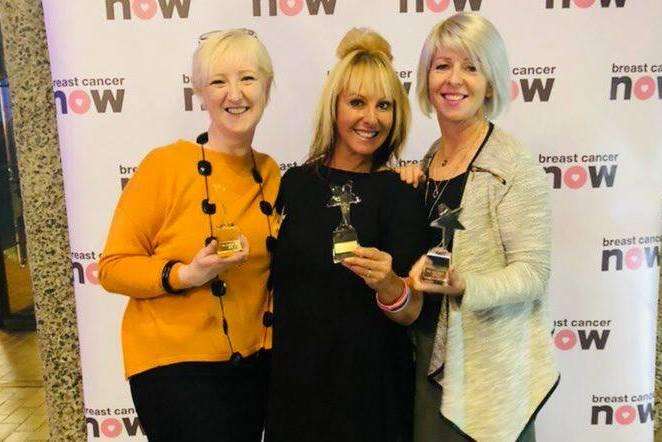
[129,352,270,442]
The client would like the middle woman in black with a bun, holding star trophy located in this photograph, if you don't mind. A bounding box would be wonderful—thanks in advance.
[266,29,426,442]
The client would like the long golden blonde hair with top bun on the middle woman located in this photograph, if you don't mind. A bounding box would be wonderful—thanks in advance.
[307,28,411,170]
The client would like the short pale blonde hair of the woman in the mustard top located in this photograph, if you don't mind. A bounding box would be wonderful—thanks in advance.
[191,29,274,101]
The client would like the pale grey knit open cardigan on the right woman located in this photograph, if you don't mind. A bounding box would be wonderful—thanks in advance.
[423,127,559,442]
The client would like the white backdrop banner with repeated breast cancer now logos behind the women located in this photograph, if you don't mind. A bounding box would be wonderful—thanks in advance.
[43,0,662,442]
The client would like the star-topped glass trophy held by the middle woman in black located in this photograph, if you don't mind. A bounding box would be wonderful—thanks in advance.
[326,181,361,264]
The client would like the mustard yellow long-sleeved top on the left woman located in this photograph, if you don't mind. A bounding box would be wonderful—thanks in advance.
[99,140,280,377]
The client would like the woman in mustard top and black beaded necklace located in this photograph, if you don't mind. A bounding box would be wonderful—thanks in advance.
[99,29,280,442]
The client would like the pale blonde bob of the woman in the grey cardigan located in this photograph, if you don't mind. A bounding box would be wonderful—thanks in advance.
[416,12,511,120]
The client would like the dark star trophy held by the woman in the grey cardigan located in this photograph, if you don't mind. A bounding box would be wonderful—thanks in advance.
[421,203,464,285]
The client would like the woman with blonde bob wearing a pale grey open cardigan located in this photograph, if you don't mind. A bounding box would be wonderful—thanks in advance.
[392,13,559,442]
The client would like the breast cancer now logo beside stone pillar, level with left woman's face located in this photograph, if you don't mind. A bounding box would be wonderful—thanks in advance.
[53,77,126,115]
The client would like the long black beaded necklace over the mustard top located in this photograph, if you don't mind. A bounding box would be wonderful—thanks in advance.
[195,132,276,365]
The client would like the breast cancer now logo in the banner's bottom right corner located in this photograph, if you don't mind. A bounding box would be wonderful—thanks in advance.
[591,393,655,425]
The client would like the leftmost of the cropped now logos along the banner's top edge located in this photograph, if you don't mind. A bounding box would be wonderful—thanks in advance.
[106,0,191,20]
